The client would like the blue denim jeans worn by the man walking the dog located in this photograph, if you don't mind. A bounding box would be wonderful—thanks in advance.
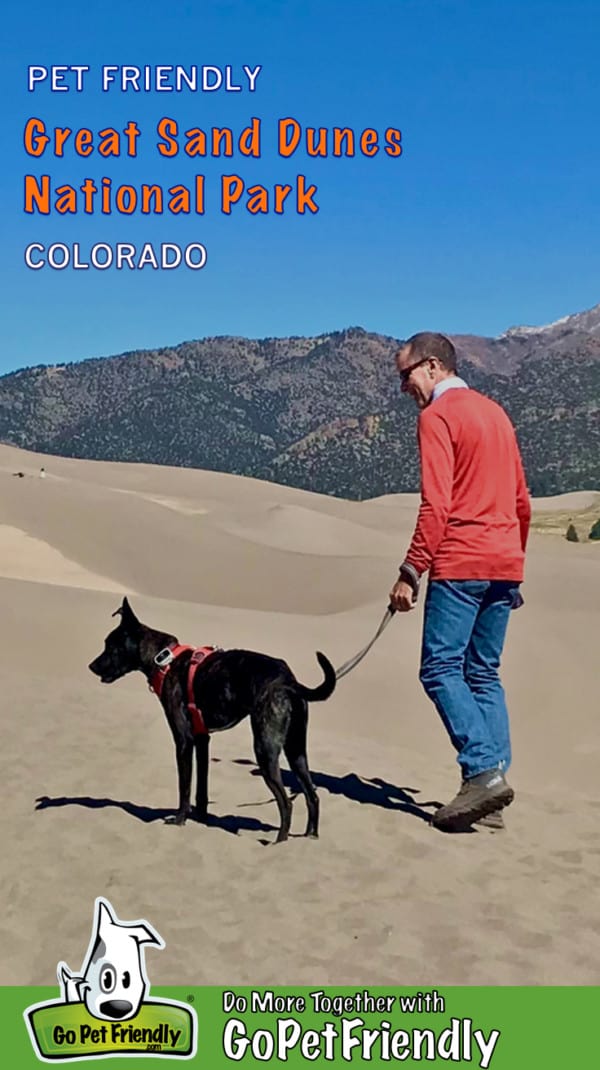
[419,580,519,778]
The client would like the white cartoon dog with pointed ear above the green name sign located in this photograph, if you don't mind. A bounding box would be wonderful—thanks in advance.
[57,897,165,1022]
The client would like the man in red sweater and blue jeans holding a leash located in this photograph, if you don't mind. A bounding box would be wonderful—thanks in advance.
[389,332,530,831]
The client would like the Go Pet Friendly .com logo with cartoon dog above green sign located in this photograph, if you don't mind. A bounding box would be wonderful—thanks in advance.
[25,897,198,1063]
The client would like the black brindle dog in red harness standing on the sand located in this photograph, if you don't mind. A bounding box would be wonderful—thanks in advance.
[89,598,336,843]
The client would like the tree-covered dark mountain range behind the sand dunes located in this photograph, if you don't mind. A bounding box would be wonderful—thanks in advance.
[0,305,600,499]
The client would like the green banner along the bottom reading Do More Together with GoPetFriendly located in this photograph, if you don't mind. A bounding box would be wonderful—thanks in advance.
[0,985,600,1070]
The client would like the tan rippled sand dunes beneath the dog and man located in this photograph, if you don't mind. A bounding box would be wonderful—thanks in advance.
[0,446,600,985]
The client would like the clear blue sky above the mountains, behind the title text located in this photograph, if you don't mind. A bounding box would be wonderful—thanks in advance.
[0,0,600,372]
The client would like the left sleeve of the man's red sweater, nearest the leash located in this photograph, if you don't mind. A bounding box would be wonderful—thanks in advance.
[404,409,455,576]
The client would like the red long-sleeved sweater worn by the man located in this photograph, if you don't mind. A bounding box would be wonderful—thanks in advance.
[405,387,530,580]
